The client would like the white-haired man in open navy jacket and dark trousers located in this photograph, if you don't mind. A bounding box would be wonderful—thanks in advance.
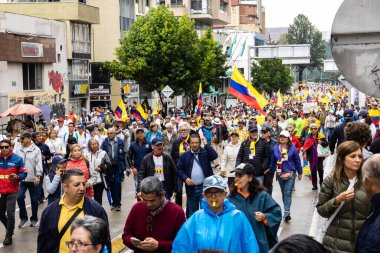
[101,128,127,211]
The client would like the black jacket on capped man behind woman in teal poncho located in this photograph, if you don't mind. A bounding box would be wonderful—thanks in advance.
[236,138,270,177]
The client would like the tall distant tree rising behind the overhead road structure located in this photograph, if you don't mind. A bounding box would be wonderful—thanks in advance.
[287,14,325,82]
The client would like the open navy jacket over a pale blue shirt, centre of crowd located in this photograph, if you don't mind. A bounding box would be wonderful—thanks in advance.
[177,144,218,181]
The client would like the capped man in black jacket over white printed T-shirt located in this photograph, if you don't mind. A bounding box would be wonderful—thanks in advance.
[137,138,178,199]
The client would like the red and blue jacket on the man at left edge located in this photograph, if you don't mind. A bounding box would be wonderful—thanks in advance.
[0,151,26,194]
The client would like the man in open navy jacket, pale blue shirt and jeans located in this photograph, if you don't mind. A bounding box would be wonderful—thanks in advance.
[177,135,218,217]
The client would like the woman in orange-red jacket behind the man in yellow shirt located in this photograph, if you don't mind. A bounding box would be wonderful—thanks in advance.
[66,144,97,198]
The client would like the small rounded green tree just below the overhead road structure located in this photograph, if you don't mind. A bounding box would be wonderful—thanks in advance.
[251,59,294,94]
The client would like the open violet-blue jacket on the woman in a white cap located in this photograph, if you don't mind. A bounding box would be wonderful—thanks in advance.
[269,144,302,175]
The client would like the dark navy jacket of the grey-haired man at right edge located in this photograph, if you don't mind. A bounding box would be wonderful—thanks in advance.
[355,193,380,253]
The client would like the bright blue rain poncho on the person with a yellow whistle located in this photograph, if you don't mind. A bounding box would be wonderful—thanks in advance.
[172,199,260,253]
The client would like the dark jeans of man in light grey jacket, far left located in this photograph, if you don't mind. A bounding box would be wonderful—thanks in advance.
[17,182,39,221]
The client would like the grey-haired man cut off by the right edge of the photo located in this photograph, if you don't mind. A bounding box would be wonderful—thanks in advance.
[355,154,380,253]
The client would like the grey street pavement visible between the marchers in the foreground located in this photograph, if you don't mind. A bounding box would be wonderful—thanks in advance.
[0,177,316,253]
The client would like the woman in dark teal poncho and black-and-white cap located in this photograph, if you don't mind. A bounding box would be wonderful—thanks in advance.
[227,163,281,253]
